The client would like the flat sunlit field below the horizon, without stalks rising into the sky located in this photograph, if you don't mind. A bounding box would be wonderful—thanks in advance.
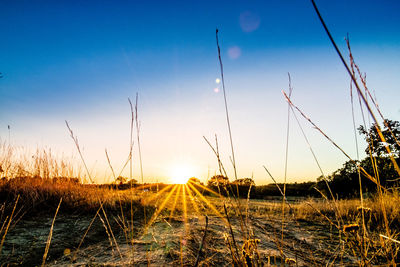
[0,174,400,266]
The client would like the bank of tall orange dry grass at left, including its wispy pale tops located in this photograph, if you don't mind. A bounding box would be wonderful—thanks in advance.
[0,142,147,216]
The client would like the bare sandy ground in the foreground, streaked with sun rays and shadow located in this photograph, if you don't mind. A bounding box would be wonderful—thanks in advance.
[0,208,355,266]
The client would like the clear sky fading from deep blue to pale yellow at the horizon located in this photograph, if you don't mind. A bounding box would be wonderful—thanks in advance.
[0,0,400,184]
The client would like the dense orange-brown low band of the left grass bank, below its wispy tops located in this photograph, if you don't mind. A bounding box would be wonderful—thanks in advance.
[0,177,144,215]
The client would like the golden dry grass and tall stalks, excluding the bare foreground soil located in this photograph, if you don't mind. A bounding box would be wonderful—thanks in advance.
[0,4,400,266]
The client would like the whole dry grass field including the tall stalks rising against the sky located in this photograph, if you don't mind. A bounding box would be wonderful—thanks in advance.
[0,1,400,266]
